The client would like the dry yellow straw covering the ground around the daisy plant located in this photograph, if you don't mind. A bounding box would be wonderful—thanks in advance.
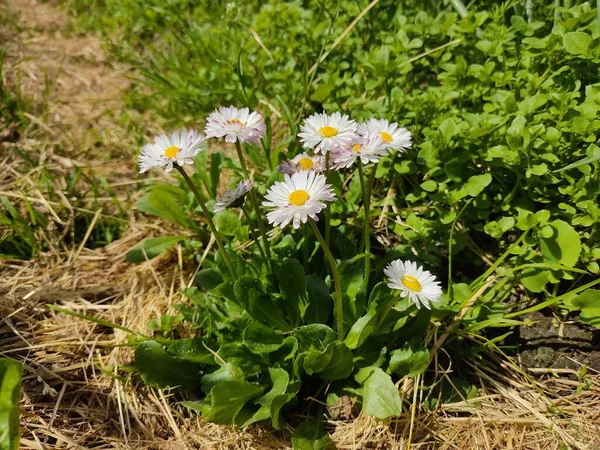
[0,0,600,450]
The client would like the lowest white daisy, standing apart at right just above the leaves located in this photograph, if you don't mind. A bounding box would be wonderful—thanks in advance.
[383,259,442,309]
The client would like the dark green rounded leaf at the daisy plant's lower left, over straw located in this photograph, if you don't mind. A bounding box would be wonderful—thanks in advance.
[135,341,202,388]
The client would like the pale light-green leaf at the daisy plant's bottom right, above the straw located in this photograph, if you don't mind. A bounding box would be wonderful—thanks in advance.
[356,367,402,419]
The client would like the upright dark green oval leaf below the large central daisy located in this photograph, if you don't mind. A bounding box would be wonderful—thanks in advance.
[278,258,308,327]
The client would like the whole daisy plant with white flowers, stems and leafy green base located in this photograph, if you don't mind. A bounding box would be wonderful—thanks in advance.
[129,106,444,436]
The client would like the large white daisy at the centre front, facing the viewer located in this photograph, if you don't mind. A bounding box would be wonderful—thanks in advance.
[263,170,335,229]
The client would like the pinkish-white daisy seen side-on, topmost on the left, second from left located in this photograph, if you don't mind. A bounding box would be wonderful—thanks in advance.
[204,106,266,144]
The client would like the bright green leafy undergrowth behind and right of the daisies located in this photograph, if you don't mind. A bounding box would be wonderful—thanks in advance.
[65,0,600,308]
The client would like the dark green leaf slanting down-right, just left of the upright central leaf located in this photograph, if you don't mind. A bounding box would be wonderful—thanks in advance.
[233,276,290,330]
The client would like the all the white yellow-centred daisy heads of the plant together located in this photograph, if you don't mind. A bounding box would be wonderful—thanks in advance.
[139,106,442,309]
